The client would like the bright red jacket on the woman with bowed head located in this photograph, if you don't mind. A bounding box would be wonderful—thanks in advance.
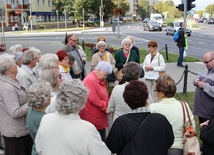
[80,71,109,129]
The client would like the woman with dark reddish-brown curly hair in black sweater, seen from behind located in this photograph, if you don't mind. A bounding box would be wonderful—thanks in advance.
[106,80,174,155]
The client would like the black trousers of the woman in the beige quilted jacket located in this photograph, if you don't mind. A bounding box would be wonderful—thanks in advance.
[3,135,33,155]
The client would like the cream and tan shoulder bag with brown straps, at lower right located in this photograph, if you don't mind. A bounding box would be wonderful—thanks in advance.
[181,101,201,155]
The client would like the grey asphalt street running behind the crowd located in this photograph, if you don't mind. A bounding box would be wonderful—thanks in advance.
[2,22,214,59]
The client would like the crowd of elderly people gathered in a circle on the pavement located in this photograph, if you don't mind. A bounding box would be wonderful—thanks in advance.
[0,30,214,155]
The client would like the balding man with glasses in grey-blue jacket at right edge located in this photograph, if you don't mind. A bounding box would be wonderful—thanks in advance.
[193,51,214,123]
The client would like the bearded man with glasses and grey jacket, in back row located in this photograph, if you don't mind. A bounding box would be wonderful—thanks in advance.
[62,33,87,80]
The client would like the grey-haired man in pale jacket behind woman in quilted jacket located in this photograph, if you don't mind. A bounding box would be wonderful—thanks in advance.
[16,50,40,90]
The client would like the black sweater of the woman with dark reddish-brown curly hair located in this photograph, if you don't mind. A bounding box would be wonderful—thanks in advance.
[106,112,174,155]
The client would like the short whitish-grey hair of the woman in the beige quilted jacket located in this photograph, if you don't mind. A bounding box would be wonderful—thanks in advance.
[0,53,16,75]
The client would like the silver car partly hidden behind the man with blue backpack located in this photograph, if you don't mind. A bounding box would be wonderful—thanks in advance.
[165,22,192,36]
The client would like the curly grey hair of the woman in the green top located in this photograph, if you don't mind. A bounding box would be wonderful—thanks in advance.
[28,81,52,109]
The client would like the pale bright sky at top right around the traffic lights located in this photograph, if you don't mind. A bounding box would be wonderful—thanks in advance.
[173,0,214,10]
